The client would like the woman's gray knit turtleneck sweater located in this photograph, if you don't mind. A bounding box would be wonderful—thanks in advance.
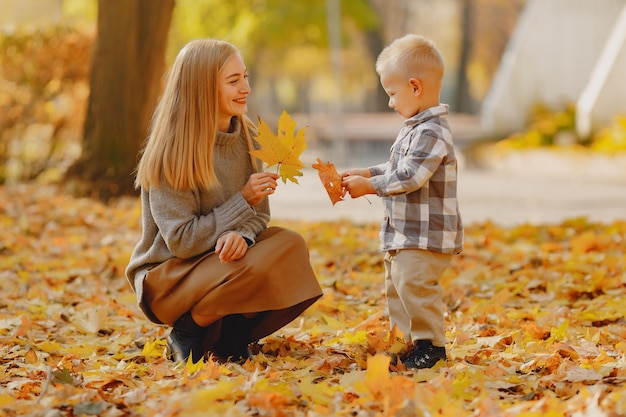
[126,118,270,292]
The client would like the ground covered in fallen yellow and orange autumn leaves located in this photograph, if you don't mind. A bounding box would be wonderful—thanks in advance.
[0,185,626,417]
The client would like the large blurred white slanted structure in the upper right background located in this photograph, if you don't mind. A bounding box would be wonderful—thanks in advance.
[481,0,626,139]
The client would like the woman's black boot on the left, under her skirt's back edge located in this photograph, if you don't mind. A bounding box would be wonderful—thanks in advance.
[166,312,206,363]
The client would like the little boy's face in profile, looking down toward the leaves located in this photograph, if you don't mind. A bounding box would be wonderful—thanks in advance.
[380,70,425,119]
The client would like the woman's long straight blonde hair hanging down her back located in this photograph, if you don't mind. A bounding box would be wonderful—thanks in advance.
[135,39,250,191]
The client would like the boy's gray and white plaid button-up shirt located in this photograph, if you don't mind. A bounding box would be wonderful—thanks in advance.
[369,104,463,254]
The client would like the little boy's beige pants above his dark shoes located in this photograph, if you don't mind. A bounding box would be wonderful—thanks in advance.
[384,249,452,346]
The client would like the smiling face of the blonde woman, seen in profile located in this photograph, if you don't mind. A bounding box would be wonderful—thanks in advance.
[217,54,250,132]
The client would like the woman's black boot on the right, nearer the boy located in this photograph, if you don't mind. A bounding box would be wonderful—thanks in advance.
[214,314,254,363]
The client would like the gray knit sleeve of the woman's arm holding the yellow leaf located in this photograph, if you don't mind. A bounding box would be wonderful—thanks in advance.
[150,183,256,259]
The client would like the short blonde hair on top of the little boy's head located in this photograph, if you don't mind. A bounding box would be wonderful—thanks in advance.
[376,34,444,79]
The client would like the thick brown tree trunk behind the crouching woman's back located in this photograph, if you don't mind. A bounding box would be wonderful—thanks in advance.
[67,0,175,200]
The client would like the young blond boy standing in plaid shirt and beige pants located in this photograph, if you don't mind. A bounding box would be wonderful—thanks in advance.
[342,35,463,369]
